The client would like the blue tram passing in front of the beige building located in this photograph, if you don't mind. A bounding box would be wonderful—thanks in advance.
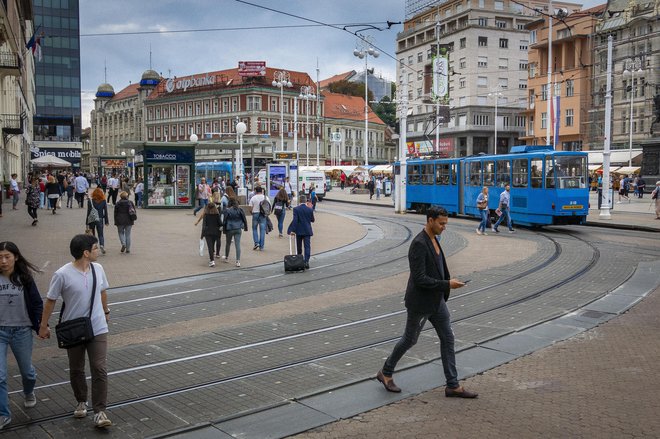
[406,145,589,226]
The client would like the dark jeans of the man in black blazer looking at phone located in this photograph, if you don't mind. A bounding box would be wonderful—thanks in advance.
[383,300,458,389]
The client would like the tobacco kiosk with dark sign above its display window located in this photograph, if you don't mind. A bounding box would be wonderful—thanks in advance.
[135,142,195,208]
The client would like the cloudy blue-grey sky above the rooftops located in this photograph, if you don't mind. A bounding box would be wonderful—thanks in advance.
[80,0,605,128]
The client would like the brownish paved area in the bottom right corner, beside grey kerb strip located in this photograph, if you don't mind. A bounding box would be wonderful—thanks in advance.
[295,289,660,439]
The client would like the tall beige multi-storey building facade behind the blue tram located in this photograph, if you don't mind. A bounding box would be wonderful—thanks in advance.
[396,0,581,157]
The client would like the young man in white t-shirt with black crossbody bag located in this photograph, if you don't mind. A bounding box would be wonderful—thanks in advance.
[39,234,112,428]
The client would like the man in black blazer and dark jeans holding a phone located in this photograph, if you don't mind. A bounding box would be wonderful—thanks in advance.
[376,206,477,398]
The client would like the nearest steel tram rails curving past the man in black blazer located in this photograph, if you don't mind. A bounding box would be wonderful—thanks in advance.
[7,219,600,430]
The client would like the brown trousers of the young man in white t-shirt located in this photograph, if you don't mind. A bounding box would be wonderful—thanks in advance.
[66,333,108,413]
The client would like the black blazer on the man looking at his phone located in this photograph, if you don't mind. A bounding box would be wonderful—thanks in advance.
[405,230,450,314]
